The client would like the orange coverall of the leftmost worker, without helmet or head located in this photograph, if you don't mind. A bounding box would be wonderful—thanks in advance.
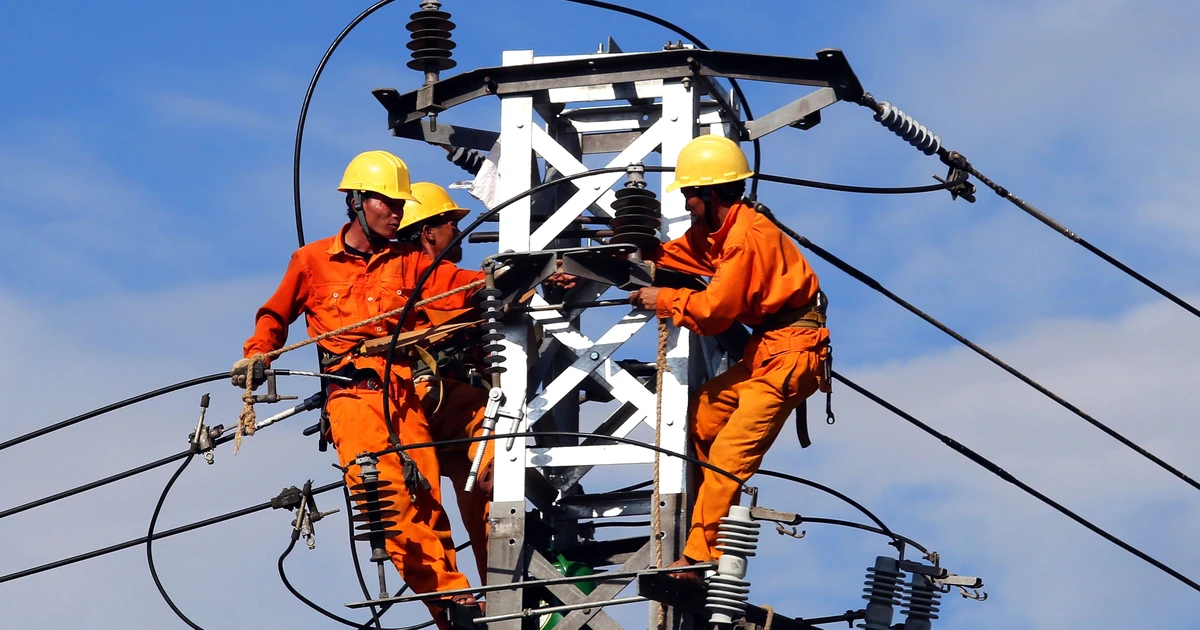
[244,223,469,628]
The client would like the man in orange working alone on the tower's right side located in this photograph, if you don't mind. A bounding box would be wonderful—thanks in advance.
[630,136,829,577]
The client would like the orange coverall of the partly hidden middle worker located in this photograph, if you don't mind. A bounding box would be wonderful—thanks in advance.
[401,245,494,576]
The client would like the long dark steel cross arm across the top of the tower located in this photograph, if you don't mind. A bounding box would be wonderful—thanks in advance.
[372,49,863,130]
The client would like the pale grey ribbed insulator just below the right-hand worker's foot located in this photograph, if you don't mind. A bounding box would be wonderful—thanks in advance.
[704,505,760,625]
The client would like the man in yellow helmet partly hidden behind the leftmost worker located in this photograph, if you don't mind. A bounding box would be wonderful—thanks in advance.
[397,182,493,576]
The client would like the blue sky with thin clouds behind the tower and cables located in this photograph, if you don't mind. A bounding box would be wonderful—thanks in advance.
[0,0,1200,629]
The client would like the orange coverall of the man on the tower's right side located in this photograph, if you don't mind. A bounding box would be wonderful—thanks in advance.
[655,203,829,562]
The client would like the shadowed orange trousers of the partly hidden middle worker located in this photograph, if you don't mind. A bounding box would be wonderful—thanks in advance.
[415,378,494,581]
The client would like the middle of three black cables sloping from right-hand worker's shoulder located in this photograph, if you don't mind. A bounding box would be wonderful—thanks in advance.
[755,204,1200,490]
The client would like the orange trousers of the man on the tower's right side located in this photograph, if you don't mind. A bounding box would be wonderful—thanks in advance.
[683,349,822,562]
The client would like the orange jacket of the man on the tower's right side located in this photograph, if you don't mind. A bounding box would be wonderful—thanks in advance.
[656,202,829,362]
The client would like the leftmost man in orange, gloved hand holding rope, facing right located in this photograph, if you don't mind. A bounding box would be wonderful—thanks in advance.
[232,151,475,629]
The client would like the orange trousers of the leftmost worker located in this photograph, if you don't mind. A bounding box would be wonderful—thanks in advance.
[325,376,470,630]
